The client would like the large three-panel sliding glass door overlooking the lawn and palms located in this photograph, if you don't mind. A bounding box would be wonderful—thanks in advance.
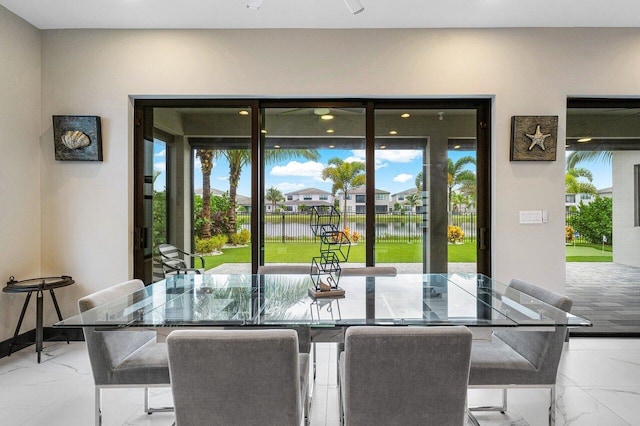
[134,99,490,282]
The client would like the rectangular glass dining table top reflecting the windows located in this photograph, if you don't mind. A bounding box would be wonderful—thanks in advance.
[54,274,591,342]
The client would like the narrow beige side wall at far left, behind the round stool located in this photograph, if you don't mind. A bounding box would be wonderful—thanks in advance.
[0,7,41,341]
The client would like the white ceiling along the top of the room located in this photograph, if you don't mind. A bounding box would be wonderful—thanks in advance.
[0,0,640,29]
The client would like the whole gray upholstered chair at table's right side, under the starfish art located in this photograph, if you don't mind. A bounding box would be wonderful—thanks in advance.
[469,279,573,425]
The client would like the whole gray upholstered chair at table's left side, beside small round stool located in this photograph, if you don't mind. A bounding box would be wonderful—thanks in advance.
[78,280,173,425]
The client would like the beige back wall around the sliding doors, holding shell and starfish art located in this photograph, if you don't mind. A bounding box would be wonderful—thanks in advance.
[30,28,640,322]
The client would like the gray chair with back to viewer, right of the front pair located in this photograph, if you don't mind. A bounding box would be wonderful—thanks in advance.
[339,326,472,426]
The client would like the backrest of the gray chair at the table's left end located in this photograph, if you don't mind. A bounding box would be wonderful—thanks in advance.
[78,280,155,385]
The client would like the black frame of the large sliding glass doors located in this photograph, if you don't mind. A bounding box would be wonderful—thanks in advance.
[132,98,492,283]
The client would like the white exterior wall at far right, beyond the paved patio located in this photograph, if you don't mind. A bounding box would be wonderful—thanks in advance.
[612,151,640,267]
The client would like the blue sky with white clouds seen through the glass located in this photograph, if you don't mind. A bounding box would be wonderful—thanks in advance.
[154,143,612,196]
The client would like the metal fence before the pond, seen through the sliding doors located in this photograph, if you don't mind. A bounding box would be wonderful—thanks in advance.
[237,213,476,243]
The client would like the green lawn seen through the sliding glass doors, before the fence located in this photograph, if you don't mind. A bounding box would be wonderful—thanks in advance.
[205,242,476,269]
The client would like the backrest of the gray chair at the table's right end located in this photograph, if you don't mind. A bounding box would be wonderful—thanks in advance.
[494,279,573,384]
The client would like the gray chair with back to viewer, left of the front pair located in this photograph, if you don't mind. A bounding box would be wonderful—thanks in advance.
[167,329,309,426]
